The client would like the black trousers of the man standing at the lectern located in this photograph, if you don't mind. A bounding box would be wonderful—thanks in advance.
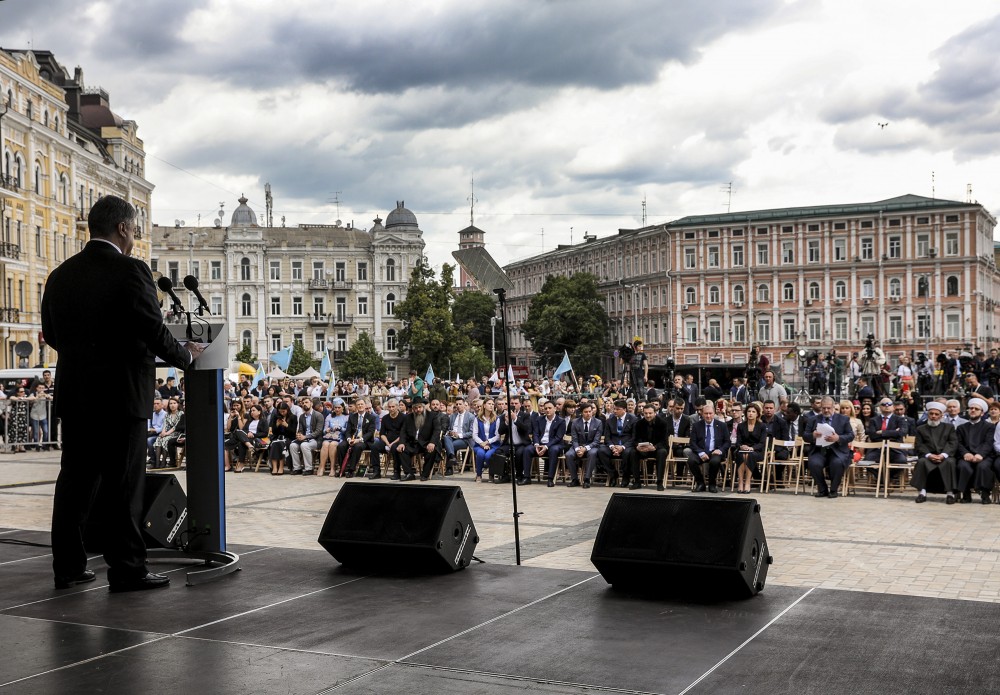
[52,417,147,584]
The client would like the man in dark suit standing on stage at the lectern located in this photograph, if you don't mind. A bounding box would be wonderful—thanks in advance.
[42,196,201,592]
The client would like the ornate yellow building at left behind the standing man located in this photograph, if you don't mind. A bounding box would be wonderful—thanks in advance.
[0,48,153,368]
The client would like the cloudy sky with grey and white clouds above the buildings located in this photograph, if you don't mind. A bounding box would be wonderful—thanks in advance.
[0,0,1000,270]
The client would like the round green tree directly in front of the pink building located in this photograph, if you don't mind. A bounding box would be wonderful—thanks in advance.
[521,273,608,375]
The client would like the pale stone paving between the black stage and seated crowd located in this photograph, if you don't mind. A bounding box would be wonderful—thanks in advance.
[0,452,1000,602]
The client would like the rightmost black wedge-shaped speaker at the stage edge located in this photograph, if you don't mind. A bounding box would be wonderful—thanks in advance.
[590,493,773,600]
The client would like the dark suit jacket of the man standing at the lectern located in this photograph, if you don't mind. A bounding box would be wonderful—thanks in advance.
[42,245,190,420]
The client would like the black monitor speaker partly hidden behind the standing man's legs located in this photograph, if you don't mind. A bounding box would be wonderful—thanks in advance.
[83,473,187,553]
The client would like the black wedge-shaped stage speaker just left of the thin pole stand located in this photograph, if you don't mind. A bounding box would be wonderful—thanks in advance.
[319,482,479,574]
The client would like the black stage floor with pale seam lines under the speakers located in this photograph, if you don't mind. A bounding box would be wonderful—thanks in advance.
[0,530,1000,695]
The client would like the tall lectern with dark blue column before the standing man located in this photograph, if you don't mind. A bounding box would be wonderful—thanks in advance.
[155,317,240,586]
